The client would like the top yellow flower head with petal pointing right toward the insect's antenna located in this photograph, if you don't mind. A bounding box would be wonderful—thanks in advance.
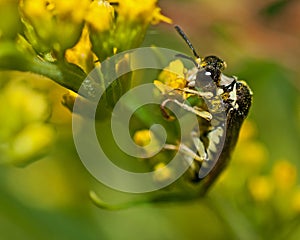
[86,0,171,61]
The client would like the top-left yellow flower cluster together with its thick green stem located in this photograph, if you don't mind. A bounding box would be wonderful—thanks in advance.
[0,0,171,91]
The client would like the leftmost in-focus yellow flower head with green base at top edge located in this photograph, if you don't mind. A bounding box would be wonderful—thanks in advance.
[20,0,90,55]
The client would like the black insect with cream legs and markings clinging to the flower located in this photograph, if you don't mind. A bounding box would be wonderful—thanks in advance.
[161,26,252,191]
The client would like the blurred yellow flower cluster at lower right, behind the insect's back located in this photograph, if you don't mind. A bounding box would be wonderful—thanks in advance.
[216,120,300,229]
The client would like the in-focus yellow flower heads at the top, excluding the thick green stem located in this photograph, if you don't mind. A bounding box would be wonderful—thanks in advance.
[20,0,170,70]
